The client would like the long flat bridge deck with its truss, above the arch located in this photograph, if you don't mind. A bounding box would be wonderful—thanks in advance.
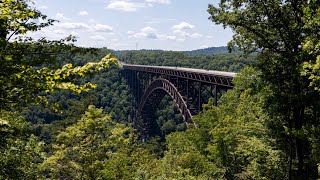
[120,63,237,88]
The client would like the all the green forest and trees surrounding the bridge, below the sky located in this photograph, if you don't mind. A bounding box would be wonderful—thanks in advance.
[0,0,320,179]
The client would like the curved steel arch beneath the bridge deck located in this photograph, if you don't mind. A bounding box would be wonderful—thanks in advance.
[135,78,192,135]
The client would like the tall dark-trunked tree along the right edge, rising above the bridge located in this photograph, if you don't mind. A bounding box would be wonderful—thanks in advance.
[208,0,320,179]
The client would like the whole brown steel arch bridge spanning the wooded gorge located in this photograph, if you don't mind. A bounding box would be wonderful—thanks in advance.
[122,64,236,136]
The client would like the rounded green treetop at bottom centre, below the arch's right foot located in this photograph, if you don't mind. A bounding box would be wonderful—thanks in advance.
[155,131,219,179]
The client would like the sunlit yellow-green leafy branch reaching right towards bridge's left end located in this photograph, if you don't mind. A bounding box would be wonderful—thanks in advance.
[11,54,117,104]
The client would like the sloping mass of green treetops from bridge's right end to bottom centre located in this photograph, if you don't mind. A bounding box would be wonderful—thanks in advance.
[131,68,287,179]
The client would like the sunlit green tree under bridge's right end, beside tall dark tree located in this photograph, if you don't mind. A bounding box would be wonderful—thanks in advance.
[195,68,285,179]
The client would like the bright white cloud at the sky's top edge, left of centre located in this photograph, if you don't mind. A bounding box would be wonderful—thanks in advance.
[106,1,145,12]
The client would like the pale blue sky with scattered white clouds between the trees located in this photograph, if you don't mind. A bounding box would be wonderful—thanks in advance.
[31,0,233,51]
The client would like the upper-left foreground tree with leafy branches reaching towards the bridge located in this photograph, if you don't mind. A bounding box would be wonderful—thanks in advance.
[0,0,116,109]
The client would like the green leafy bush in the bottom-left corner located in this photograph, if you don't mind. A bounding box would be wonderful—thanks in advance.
[0,111,45,179]
